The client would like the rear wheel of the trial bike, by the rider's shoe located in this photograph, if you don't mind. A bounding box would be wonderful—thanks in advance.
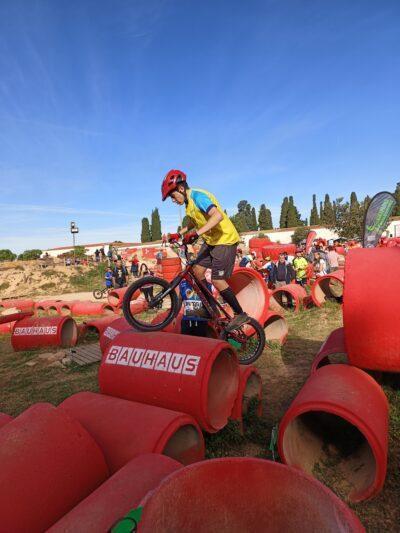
[220,318,265,365]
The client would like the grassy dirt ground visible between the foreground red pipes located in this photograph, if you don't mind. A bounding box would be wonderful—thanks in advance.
[0,300,400,532]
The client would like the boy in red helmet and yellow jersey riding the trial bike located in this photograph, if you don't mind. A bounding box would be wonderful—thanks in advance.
[161,170,249,331]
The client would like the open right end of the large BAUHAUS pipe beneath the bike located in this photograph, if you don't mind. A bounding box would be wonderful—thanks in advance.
[207,350,238,429]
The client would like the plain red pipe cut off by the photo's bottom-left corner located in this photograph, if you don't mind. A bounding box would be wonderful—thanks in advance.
[0,403,109,533]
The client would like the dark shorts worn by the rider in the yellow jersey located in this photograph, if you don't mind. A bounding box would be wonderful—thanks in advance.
[196,244,237,279]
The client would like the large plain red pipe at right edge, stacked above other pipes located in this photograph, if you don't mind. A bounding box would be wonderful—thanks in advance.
[343,248,400,372]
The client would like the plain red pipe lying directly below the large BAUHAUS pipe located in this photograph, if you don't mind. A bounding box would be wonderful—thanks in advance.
[59,392,204,473]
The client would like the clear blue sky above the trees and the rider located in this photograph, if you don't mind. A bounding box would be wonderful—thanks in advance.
[0,0,400,251]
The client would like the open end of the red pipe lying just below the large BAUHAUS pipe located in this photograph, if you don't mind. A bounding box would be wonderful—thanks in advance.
[162,424,203,465]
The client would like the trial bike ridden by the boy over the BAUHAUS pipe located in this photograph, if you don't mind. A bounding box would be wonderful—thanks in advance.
[122,242,265,365]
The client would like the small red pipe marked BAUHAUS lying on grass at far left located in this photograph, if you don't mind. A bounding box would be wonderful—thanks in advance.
[11,316,78,351]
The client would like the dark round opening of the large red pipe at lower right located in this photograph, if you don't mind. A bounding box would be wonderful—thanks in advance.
[283,411,377,501]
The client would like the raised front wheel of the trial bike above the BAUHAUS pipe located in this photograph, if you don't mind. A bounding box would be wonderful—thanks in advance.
[122,276,181,331]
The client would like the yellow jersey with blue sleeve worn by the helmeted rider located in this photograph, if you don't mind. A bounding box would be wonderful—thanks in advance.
[186,189,240,246]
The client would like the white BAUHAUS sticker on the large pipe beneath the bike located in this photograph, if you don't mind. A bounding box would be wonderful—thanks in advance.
[105,346,200,376]
